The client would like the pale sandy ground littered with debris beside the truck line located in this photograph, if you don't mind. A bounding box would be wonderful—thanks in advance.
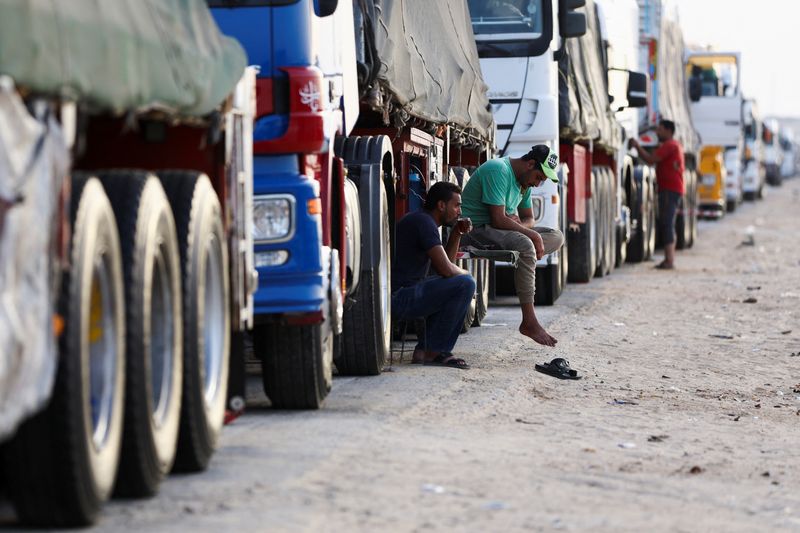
[4,180,800,532]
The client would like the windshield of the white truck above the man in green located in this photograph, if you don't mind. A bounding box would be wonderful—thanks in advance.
[469,0,553,57]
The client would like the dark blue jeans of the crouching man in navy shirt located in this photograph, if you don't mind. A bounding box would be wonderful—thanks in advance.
[392,274,475,352]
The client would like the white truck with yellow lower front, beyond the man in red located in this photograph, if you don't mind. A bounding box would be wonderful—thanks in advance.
[686,51,744,218]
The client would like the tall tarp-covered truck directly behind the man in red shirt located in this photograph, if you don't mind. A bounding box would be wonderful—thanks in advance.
[639,0,700,249]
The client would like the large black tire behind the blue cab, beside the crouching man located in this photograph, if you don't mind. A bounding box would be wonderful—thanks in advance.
[335,136,392,375]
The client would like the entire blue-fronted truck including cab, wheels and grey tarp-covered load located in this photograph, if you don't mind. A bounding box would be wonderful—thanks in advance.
[209,0,494,408]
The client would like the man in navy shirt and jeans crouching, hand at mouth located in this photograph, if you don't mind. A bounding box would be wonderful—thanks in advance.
[392,182,475,369]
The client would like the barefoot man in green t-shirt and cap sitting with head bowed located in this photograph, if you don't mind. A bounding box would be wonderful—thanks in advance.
[464,144,564,346]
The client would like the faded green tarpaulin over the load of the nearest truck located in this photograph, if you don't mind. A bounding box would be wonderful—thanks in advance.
[0,0,247,116]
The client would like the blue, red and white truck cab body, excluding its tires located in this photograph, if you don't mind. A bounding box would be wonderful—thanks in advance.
[209,0,357,324]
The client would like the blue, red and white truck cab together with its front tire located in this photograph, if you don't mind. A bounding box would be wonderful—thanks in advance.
[208,0,359,408]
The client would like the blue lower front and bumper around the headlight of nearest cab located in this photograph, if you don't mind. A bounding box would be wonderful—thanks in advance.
[253,156,326,321]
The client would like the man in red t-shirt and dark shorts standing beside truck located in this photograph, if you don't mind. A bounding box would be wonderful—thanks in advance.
[630,120,685,270]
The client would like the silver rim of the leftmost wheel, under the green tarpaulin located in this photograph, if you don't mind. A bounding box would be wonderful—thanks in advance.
[88,254,121,450]
